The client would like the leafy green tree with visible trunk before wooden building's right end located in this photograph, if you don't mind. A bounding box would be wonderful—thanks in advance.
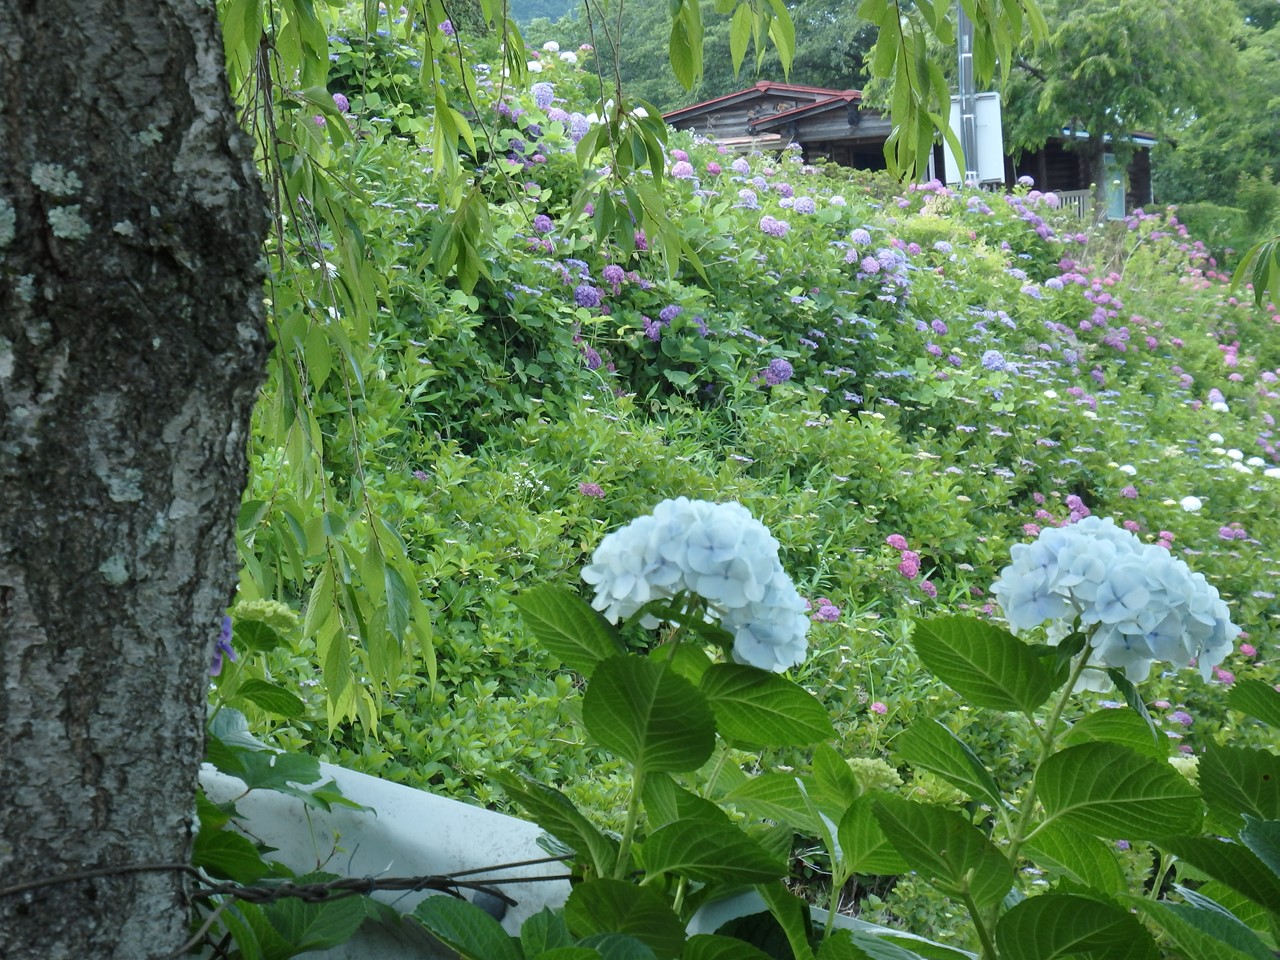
[1004,0,1239,209]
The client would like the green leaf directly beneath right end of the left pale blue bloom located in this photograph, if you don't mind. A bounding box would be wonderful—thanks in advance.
[699,663,835,746]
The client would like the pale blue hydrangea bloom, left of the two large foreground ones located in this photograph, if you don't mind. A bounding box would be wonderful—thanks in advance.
[582,497,809,673]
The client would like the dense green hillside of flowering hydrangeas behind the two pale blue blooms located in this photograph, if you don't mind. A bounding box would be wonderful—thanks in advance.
[186,4,1280,956]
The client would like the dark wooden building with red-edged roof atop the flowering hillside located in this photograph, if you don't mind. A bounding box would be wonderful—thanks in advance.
[666,81,1156,216]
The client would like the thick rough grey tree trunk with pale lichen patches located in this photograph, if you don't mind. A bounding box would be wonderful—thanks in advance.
[0,0,266,960]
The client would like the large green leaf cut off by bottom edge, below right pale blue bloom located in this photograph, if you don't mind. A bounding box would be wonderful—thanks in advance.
[996,893,1160,960]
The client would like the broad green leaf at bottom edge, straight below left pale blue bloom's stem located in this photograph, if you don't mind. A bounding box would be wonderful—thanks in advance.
[564,879,685,960]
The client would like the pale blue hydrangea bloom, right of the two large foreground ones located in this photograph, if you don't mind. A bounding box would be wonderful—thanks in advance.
[991,517,1240,690]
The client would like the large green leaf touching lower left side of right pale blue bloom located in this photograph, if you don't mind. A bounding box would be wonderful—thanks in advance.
[911,617,1055,713]
